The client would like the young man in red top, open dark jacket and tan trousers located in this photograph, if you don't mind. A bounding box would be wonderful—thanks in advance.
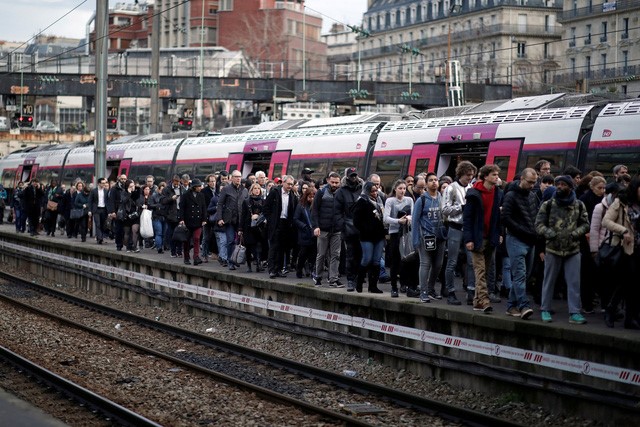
[462,164,502,314]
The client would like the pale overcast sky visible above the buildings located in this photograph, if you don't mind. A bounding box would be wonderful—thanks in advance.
[0,0,367,42]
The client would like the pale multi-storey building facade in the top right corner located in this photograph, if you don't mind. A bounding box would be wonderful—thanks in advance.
[555,0,640,98]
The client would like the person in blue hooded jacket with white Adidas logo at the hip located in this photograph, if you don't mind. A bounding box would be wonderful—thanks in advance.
[411,172,448,303]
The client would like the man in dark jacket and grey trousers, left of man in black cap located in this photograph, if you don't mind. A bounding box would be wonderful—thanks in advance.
[311,172,344,288]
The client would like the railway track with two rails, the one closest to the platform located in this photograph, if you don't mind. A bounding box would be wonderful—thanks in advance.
[1,274,514,426]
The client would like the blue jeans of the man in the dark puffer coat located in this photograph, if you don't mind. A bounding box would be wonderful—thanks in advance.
[502,233,535,310]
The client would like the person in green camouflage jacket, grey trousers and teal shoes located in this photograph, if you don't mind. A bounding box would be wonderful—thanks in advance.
[536,175,589,324]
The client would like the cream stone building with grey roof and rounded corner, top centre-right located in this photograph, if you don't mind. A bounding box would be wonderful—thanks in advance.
[358,0,562,94]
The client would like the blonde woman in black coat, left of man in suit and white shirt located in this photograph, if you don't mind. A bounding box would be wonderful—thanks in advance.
[238,183,267,273]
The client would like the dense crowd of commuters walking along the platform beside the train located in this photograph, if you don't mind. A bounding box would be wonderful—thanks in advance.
[0,160,640,329]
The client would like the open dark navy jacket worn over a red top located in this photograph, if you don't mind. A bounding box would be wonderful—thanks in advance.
[462,181,503,252]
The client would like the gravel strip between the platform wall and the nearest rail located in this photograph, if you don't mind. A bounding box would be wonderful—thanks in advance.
[0,268,601,427]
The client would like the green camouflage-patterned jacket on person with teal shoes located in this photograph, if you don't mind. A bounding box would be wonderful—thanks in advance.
[536,193,589,257]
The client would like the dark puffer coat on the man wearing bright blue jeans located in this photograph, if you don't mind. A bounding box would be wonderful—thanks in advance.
[502,185,538,246]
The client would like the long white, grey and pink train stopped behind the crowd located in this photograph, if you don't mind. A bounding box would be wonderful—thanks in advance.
[0,94,640,193]
